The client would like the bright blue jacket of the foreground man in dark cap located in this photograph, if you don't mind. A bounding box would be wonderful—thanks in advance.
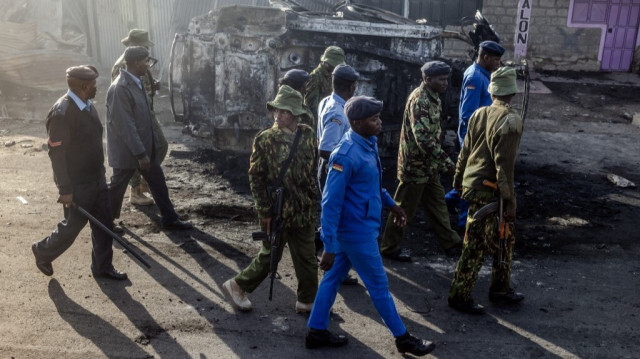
[321,130,396,253]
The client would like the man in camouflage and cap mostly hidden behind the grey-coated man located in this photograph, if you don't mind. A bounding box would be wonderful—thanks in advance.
[111,29,169,206]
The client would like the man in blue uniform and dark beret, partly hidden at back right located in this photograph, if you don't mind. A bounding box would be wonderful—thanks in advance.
[444,41,504,228]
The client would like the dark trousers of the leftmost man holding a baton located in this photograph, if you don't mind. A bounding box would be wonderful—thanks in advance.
[36,176,113,273]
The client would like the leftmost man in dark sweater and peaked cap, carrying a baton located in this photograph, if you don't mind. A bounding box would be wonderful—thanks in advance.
[31,65,127,280]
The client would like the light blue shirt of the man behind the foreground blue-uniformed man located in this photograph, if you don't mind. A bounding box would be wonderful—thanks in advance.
[318,93,351,152]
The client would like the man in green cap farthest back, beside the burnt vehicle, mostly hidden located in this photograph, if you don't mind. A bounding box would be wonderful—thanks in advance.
[304,46,344,126]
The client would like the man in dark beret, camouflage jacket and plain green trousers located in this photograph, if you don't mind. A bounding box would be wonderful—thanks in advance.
[380,61,461,262]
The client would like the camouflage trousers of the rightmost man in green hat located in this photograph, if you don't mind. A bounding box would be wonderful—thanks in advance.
[449,200,516,301]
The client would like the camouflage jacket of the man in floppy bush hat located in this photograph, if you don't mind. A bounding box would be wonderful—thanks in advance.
[249,124,320,228]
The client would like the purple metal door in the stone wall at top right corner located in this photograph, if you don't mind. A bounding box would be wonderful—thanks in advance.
[602,0,640,71]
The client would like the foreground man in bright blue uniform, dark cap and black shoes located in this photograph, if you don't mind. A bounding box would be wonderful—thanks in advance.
[305,96,435,355]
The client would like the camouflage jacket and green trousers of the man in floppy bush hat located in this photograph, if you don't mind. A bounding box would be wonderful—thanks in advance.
[234,124,319,303]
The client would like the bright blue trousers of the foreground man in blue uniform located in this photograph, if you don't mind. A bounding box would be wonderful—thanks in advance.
[307,238,407,337]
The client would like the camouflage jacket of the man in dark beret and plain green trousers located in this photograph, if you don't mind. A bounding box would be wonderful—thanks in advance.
[398,82,454,183]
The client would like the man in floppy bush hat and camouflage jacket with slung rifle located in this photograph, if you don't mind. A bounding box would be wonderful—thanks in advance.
[223,85,319,312]
